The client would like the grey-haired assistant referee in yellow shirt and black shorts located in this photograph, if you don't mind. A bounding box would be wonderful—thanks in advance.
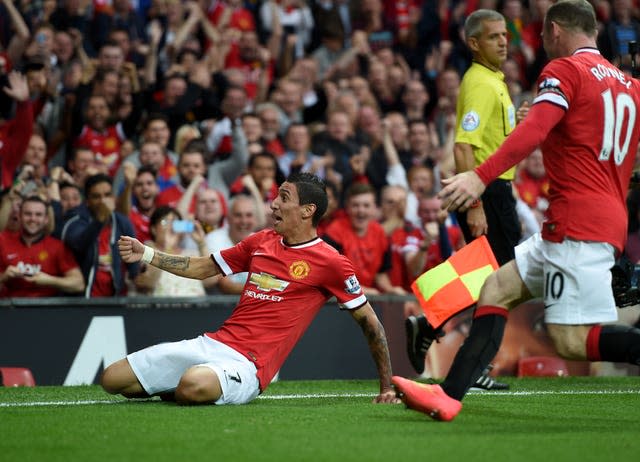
[454,10,521,265]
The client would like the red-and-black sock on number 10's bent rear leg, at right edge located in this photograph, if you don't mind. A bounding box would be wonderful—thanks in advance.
[587,325,640,366]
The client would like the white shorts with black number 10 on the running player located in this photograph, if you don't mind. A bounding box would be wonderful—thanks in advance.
[515,233,618,324]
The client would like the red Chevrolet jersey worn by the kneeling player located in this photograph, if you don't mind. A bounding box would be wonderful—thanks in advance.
[206,230,367,391]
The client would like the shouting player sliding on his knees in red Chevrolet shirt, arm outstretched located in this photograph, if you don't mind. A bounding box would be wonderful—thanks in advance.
[102,173,399,404]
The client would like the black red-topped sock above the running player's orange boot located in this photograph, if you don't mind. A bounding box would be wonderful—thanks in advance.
[441,305,509,401]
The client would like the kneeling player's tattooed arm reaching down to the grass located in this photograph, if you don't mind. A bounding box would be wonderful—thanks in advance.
[351,302,400,403]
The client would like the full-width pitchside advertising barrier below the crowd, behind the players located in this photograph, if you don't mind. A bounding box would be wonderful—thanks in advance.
[0,295,620,385]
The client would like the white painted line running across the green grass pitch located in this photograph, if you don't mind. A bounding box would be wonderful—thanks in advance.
[0,389,640,408]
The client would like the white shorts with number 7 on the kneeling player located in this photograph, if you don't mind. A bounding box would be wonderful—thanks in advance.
[127,335,260,404]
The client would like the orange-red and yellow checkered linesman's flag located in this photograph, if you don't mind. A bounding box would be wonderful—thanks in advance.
[411,236,498,329]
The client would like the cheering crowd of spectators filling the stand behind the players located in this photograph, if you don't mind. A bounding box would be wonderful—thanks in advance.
[0,0,640,297]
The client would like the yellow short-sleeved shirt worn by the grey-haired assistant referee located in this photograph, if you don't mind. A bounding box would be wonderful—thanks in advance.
[456,62,516,180]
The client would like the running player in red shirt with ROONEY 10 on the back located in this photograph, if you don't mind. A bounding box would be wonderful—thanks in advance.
[393,0,640,420]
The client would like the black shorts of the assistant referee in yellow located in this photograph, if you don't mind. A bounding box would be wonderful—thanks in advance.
[457,179,522,266]
